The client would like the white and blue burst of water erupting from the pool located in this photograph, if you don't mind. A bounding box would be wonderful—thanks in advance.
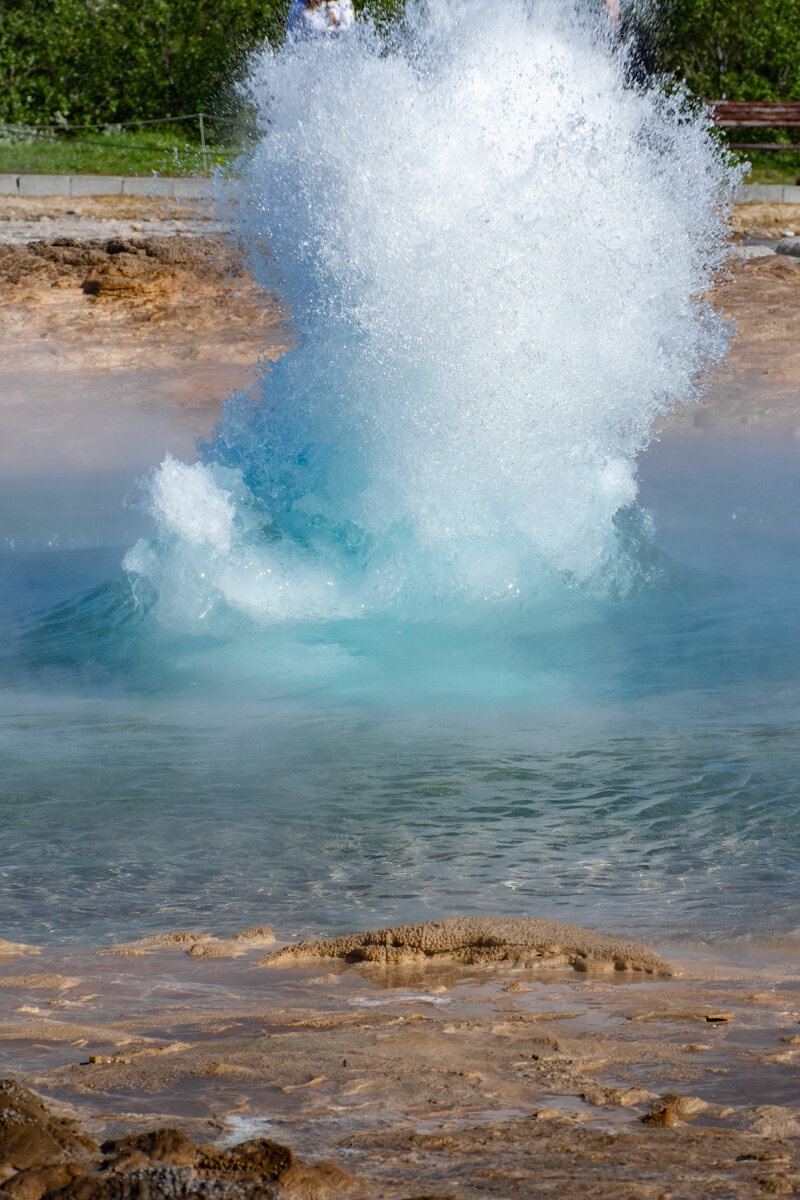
[126,0,728,629]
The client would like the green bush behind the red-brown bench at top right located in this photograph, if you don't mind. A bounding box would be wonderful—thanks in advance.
[652,0,800,100]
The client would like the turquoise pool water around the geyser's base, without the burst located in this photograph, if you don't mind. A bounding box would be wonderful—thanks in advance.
[0,436,800,943]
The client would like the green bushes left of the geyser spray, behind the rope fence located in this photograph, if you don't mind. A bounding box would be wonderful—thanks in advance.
[0,0,288,124]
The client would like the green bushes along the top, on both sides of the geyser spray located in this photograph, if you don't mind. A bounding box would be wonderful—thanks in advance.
[0,0,800,139]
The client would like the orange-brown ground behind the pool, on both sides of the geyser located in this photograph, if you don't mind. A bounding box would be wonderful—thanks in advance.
[0,197,800,437]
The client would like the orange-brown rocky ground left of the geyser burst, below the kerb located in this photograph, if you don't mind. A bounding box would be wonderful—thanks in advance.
[0,197,290,432]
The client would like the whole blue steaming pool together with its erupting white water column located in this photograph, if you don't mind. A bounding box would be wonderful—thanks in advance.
[0,0,800,941]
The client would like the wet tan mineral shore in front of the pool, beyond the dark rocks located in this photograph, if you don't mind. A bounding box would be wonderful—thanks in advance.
[0,928,800,1200]
